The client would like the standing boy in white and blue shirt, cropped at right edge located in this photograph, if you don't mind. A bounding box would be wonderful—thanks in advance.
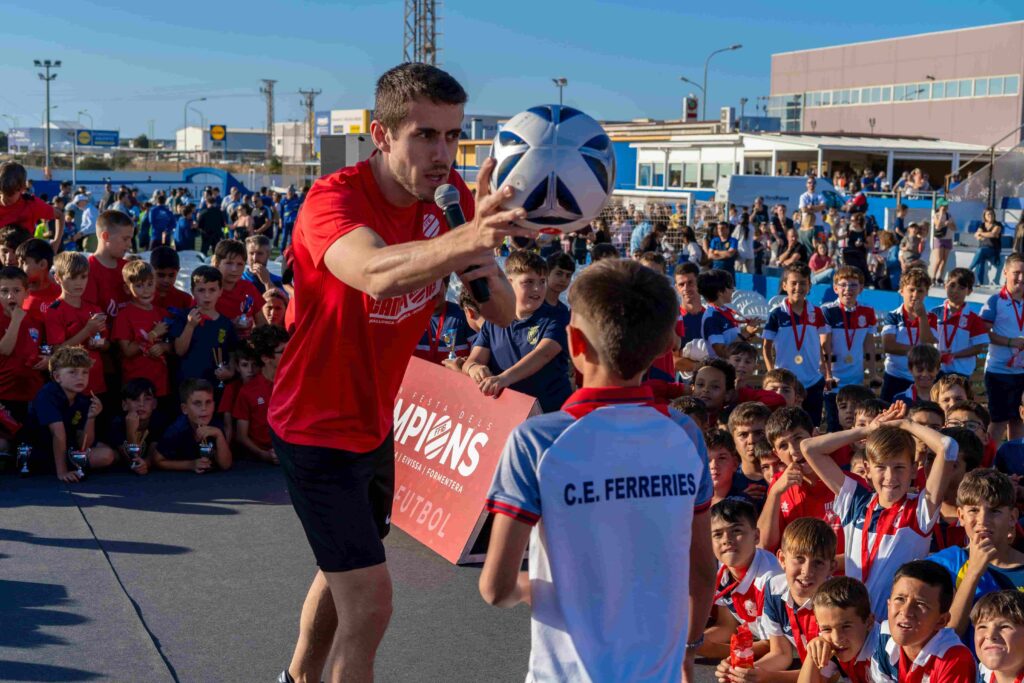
[981,253,1024,443]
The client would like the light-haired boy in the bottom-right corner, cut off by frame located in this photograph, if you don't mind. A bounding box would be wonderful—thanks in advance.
[971,591,1024,683]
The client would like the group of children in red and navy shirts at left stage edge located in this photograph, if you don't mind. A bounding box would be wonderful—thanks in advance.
[0,200,291,482]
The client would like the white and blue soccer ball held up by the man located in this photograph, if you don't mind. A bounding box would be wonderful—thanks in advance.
[490,104,615,233]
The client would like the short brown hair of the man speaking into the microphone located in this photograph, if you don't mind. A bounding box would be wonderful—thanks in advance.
[374,61,468,134]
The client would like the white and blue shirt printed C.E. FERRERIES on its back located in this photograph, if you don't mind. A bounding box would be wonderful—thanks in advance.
[486,386,713,683]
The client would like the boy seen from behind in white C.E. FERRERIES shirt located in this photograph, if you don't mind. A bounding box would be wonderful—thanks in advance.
[480,259,715,683]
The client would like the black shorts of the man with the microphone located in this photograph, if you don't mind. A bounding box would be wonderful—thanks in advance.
[273,434,394,571]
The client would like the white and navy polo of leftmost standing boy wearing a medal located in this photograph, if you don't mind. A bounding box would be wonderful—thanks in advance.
[762,301,825,387]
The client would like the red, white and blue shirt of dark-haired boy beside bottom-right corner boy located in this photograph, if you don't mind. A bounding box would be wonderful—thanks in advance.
[870,620,977,683]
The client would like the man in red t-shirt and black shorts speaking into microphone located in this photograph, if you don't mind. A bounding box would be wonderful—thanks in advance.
[268,63,536,683]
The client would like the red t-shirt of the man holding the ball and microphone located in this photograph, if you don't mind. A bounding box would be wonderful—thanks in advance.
[268,161,473,453]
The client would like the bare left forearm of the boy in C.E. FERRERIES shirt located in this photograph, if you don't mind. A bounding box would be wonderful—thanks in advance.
[479,514,532,607]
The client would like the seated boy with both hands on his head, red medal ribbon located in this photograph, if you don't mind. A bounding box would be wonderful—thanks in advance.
[801,401,958,616]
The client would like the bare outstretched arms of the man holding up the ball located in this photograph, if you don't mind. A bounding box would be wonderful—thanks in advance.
[324,159,537,326]
